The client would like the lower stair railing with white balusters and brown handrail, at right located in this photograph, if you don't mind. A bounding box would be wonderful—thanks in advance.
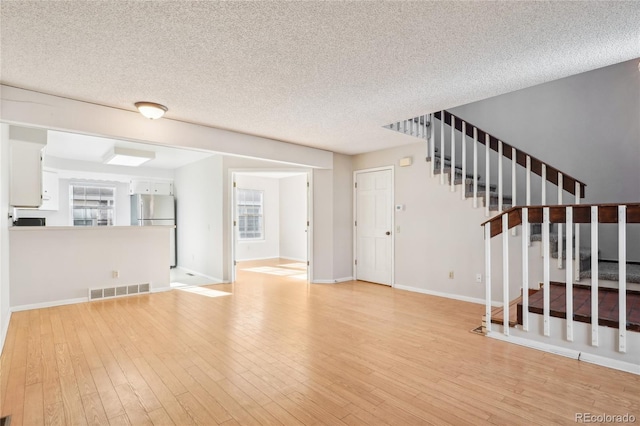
[482,203,640,353]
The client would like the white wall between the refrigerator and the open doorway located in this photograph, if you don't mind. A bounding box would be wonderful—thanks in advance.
[174,155,224,281]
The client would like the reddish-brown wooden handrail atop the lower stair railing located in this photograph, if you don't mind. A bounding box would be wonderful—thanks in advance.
[482,203,640,238]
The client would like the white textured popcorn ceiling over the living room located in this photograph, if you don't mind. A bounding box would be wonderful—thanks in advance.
[0,1,640,154]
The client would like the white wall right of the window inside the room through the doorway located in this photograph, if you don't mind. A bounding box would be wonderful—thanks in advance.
[280,174,307,262]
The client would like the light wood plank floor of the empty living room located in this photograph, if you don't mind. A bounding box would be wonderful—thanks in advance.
[0,258,640,426]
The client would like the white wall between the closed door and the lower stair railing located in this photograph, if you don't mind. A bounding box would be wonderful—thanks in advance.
[353,142,485,300]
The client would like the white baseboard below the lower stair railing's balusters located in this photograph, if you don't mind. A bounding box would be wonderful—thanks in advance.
[487,331,640,375]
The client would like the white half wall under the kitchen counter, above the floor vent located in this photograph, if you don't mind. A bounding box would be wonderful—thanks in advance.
[9,226,170,309]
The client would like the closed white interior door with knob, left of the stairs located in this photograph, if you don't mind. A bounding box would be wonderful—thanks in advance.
[355,170,393,285]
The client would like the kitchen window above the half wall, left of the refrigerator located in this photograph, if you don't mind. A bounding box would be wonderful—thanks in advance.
[70,184,116,226]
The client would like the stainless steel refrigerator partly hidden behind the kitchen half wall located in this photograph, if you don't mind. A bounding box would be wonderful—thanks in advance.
[131,194,176,267]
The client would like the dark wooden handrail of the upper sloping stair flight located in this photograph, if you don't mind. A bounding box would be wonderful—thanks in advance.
[434,111,587,198]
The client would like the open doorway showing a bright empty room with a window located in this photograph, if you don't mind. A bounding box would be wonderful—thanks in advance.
[230,169,311,282]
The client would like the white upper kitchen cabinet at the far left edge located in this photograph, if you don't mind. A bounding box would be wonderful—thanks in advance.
[9,140,44,207]
